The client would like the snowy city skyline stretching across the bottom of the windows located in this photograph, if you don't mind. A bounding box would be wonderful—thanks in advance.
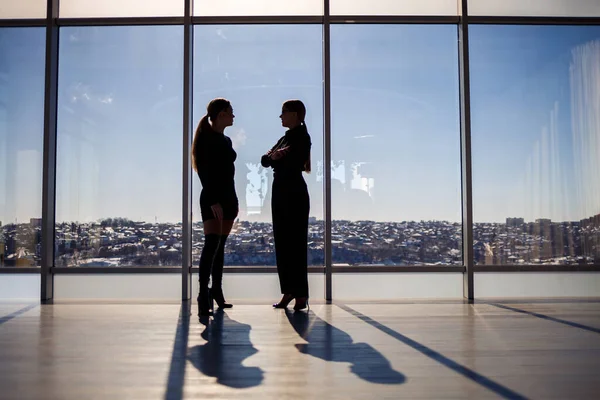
[0,214,600,267]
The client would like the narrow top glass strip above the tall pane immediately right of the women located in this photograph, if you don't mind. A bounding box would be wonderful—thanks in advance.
[329,0,460,15]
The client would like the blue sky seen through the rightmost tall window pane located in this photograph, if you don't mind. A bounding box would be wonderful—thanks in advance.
[470,26,600,221]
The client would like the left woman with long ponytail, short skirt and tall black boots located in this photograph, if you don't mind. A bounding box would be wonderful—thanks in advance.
[192,99,239,316]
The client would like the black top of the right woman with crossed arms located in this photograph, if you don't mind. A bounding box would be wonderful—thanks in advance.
[260,124,311,176]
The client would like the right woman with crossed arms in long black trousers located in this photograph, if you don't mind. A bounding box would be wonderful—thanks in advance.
[261,100,311,311]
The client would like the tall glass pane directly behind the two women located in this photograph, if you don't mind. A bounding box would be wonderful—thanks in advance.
[193,25,324,265]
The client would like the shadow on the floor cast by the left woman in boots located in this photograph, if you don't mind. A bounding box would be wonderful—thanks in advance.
[188,310,264,389]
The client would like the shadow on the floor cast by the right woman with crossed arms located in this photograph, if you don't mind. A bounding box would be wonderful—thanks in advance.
[286,310,406,385]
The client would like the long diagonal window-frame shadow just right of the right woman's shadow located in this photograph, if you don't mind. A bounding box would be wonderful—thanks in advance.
[337,304,526,400]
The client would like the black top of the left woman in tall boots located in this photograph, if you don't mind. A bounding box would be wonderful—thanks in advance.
[194,130,237,205]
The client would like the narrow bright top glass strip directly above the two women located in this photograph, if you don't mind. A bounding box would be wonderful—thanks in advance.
[194,0,323,16]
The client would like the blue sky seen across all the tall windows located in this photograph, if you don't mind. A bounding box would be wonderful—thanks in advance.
[0,25,600,223]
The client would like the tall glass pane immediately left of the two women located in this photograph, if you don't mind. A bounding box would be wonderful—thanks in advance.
[55,26,183,267]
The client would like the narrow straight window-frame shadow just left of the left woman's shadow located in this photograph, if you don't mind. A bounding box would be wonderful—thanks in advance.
[165,301,190,400]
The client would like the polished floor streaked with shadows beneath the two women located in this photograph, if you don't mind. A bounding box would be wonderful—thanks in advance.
[0,300,600,400]
